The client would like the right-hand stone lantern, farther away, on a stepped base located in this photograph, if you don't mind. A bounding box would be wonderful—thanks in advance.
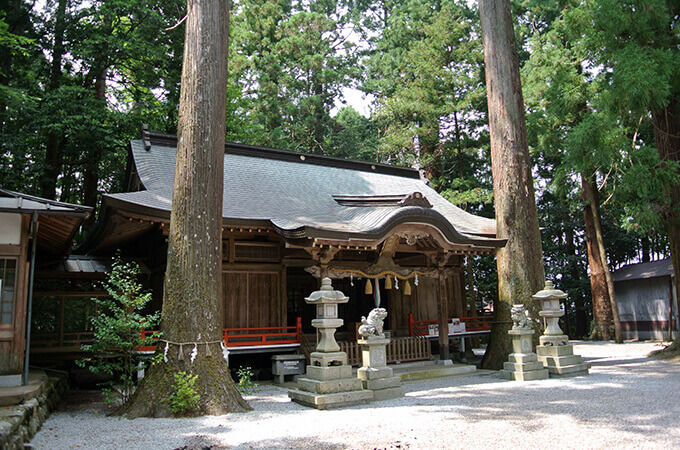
[532,280,590,376]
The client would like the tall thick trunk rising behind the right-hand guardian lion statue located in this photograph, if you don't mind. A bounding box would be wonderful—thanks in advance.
[479,0,545,369]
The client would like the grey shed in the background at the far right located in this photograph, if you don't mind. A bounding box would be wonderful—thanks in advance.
[614,258,678,340]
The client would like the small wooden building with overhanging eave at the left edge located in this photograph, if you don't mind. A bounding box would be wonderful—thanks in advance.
[0,189,91,385]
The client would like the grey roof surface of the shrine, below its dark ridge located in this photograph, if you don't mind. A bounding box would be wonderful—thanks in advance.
[106,140,500,247]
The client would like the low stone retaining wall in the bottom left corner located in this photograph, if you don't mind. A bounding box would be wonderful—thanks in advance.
[0,377,68,450]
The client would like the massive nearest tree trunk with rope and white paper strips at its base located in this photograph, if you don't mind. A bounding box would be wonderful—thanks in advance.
[121,0,249,417]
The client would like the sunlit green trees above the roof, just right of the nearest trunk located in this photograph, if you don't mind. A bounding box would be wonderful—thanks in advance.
[230,0,358,154]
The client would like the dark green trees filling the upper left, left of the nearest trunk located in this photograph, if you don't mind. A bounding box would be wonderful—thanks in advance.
[0,0,185,218]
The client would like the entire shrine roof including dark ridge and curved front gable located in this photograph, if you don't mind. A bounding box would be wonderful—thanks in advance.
[81,132,505,252]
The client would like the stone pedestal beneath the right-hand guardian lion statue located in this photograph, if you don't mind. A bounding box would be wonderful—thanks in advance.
[500,327,549,381]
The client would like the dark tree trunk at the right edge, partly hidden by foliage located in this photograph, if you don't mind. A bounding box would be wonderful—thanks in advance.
[652,97,680,349]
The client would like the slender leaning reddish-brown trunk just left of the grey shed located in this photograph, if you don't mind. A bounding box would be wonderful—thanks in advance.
[581,174,614,341]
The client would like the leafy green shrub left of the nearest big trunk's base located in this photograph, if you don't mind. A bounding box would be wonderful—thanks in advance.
[77,256,160,403]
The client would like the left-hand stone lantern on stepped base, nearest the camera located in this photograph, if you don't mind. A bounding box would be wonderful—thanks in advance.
[288,278,373,409]
